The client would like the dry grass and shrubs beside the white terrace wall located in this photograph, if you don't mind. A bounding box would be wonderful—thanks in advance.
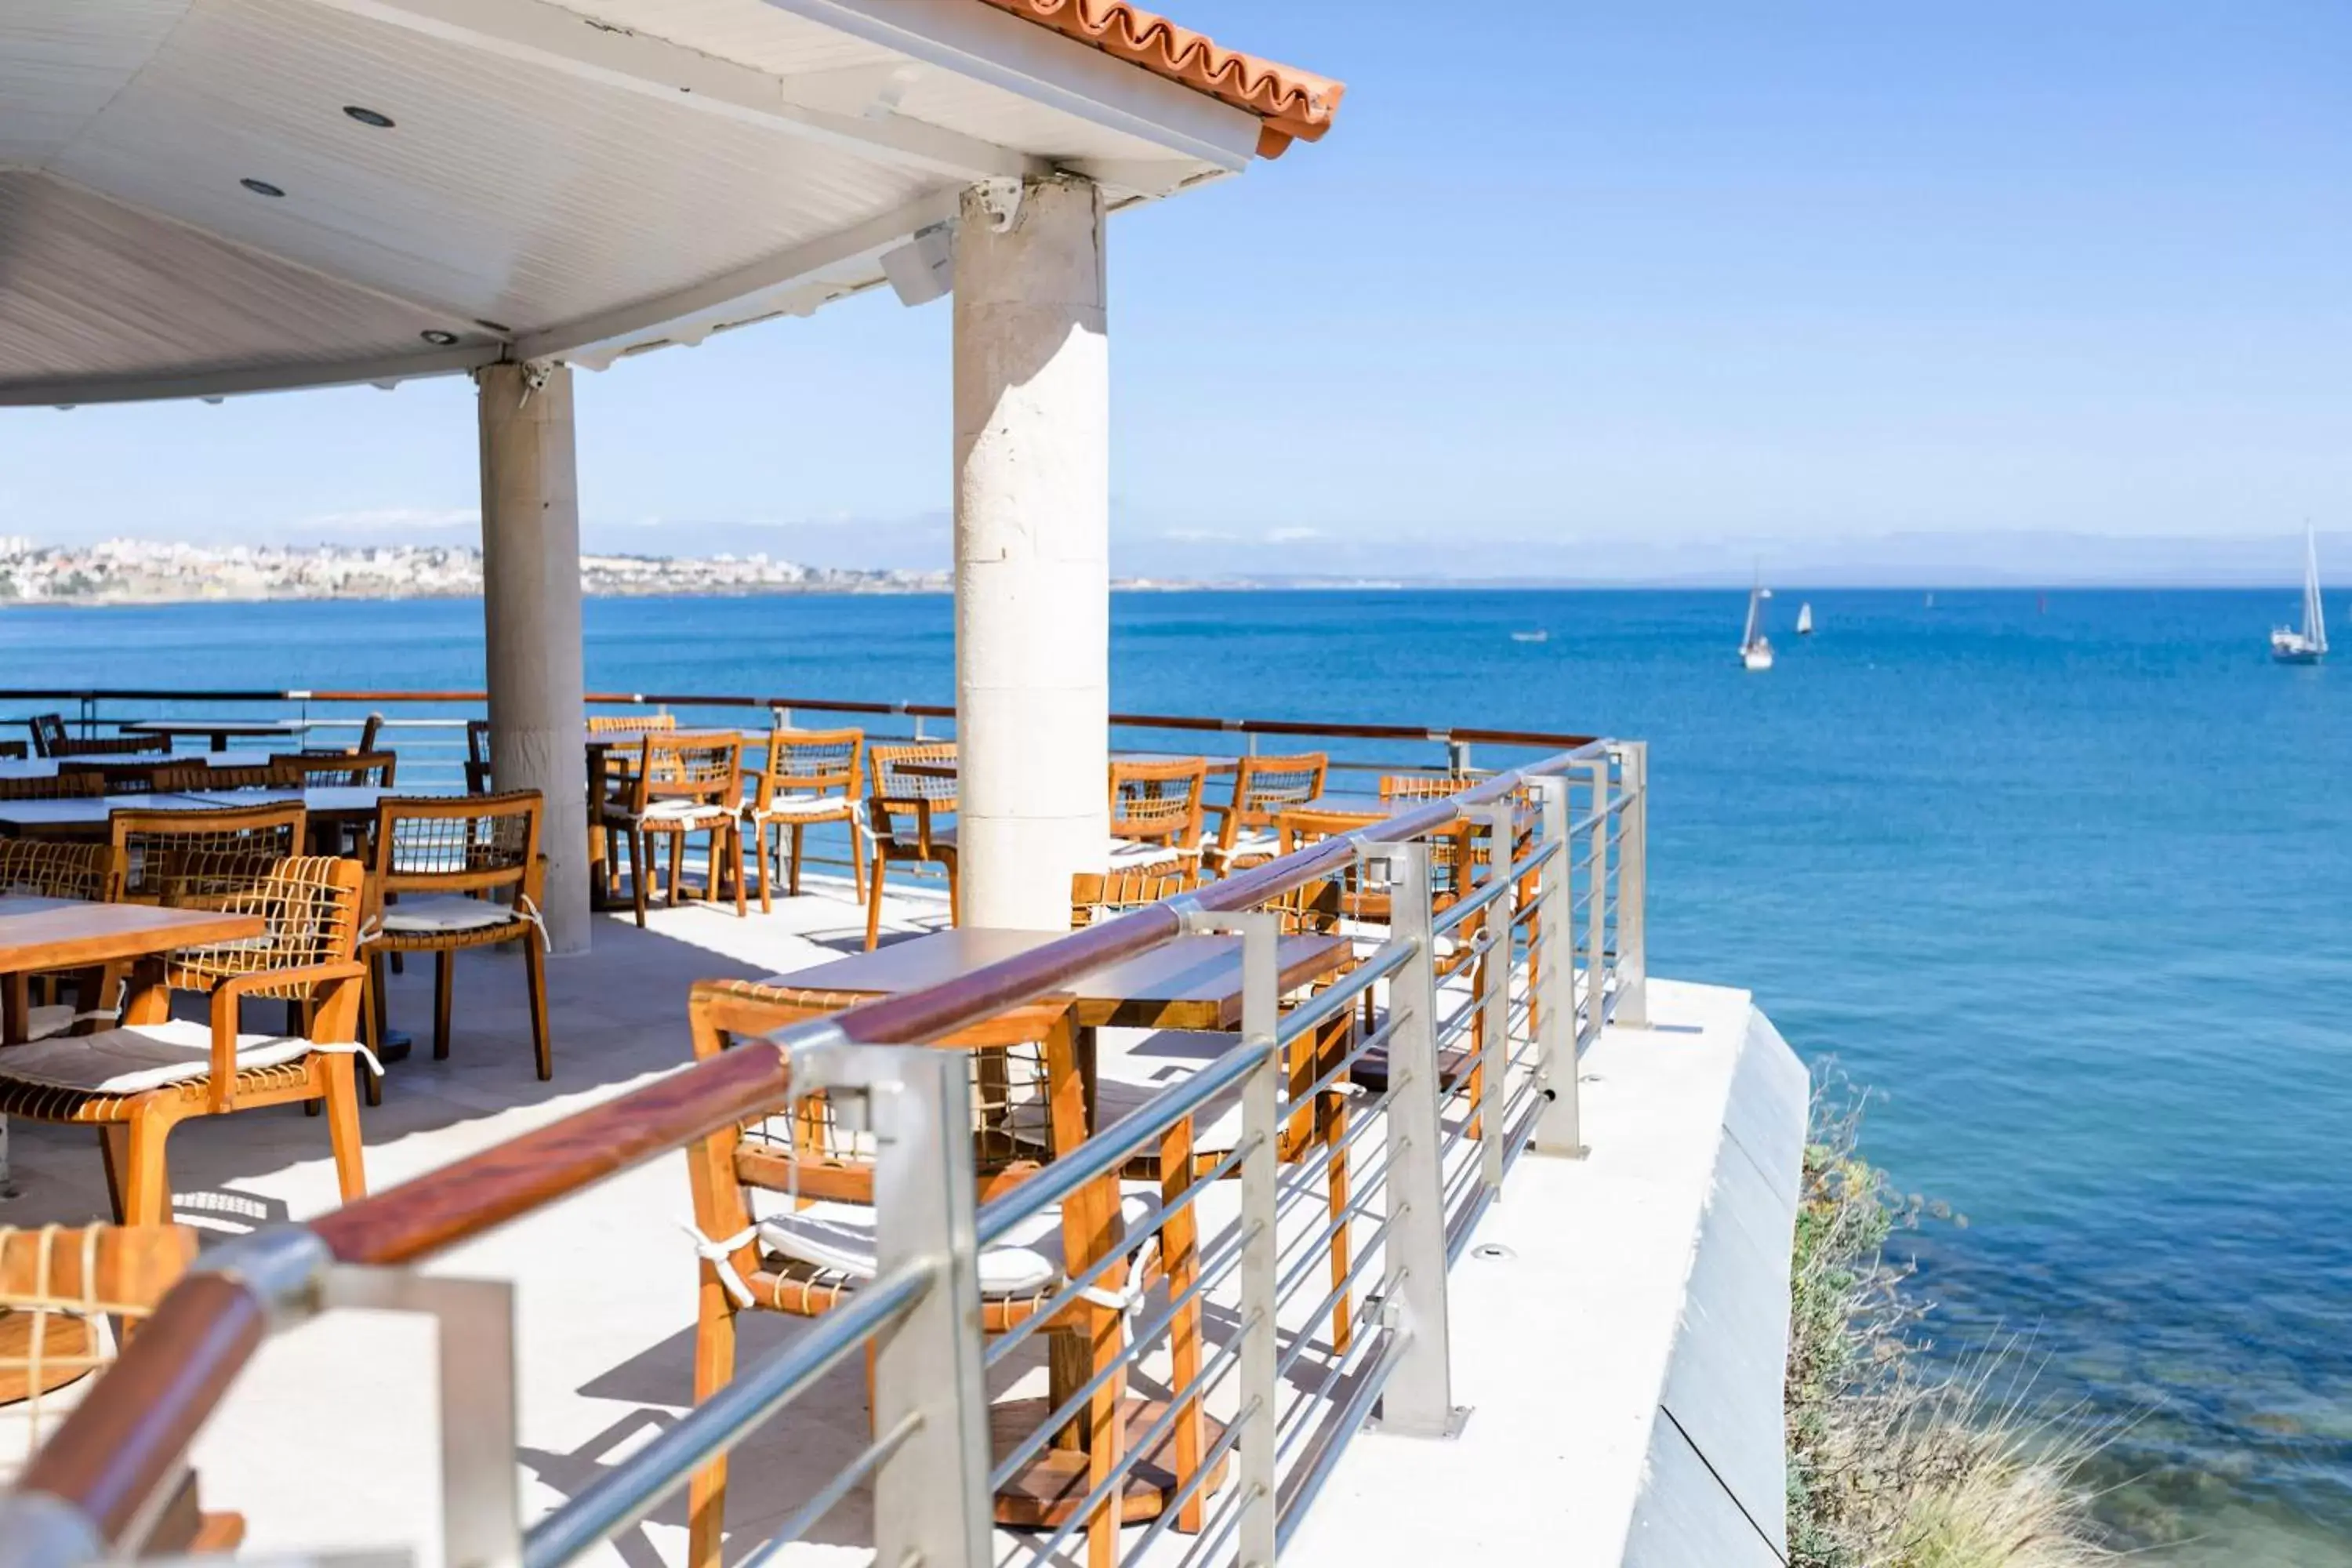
[1788,1079,2114,1568]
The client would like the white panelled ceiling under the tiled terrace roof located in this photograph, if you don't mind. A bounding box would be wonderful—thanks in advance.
[0,0,1256,405]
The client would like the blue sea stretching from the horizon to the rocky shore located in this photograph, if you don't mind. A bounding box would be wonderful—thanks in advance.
[0,590,2352,1563]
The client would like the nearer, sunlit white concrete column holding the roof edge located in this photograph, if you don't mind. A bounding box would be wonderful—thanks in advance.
[955,174,1110,931]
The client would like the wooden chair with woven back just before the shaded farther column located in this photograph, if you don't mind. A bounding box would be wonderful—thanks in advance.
[362,789,555,1105]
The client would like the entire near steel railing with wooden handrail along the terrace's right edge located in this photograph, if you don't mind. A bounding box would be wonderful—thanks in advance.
[0,741,1646,1568]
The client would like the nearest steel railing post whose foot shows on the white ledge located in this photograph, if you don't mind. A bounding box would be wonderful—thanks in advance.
[1371,839,1470,1436]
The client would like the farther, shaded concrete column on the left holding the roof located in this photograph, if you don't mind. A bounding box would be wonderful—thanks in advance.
[475,365,588,952]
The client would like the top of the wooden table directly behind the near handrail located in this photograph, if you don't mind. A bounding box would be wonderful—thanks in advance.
[764,926,1355,1029]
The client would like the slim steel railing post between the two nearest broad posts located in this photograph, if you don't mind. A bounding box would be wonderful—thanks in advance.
[1223,912,1282,1568]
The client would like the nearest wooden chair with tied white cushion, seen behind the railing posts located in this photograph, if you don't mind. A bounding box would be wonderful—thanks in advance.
[687,980,1207,1568]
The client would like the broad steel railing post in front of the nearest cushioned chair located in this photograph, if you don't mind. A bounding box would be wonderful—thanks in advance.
[861,1046,995,1568]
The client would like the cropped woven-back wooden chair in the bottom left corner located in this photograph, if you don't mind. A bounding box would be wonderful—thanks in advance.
[0,1225,245,1556]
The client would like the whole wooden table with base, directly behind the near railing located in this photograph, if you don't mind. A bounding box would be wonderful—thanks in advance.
[762,926,1355,1526]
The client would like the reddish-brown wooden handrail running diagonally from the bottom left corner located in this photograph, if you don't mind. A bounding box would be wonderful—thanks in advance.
[0,743,1599,1549]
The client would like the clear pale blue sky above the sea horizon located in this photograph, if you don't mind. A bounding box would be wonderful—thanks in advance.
[0,0,2352,574]
